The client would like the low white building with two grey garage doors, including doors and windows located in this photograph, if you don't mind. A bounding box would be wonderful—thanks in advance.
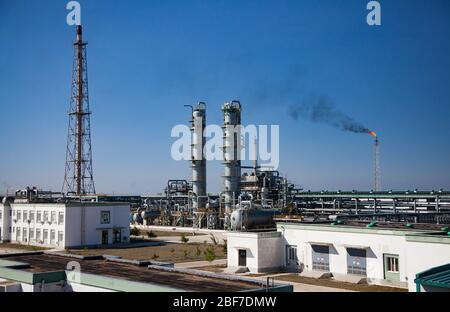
[228,223,450,291]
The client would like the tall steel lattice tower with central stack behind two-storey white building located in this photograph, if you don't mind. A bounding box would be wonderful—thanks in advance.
[63,26,95,196]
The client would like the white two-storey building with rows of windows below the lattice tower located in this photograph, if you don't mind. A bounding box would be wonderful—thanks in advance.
[0,199,130,249]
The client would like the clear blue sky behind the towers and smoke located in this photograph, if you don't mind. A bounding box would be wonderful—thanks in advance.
[0,0,450,193]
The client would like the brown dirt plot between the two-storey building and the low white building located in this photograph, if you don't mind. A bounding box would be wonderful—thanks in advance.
[68,243,226,263]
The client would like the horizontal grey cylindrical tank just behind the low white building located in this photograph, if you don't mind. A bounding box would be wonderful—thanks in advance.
[231,208,277,231]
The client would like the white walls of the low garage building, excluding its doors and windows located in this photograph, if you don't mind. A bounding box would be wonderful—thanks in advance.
[228,223,450,291]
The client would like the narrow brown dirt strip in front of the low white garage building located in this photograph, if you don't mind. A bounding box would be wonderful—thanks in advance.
[275,274,408,292]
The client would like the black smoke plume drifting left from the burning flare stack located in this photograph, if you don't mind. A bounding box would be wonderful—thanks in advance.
[289,96,370,133]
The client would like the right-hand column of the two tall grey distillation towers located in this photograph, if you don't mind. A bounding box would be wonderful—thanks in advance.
[222,101,242,215]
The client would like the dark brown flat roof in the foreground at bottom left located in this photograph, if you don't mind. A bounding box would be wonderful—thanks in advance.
[0,254,262,292]
